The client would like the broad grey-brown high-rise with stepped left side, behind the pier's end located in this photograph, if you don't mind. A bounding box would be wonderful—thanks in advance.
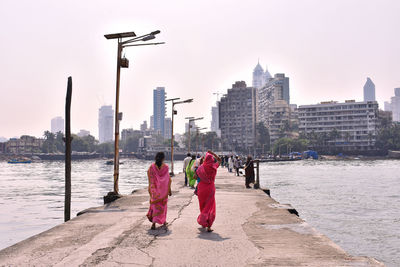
[218,81,256,153]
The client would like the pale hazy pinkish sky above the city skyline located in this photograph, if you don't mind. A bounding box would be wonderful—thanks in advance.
[0,0,400,140]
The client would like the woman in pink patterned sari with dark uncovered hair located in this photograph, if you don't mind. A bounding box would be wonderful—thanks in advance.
[147,152,171,230]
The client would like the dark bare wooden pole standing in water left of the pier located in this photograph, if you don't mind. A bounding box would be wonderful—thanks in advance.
[64,77,72,222]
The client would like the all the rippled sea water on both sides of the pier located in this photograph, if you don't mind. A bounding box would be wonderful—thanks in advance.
[0,160,400,266]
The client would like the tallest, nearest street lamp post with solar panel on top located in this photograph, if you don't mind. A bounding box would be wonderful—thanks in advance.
[104,31,164,203]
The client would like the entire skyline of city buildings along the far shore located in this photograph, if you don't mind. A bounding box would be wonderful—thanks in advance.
[0,63,400,157]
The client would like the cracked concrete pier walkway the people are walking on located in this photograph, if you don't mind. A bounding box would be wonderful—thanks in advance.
[0,168,384,266]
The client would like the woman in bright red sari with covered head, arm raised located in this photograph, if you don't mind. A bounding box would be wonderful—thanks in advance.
[196,150,221,232]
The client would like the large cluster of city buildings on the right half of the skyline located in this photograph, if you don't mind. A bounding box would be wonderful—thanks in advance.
[211,63,386,152]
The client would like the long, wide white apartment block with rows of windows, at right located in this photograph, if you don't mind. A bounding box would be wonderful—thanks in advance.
[298,100,378,151]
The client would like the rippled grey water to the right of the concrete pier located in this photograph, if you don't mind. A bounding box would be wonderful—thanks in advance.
[260,160,400,267]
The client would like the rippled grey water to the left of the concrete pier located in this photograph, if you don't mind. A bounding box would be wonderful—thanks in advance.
[0,159,182,252]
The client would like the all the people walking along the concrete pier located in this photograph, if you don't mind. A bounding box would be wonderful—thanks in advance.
[147,150,254,232]
